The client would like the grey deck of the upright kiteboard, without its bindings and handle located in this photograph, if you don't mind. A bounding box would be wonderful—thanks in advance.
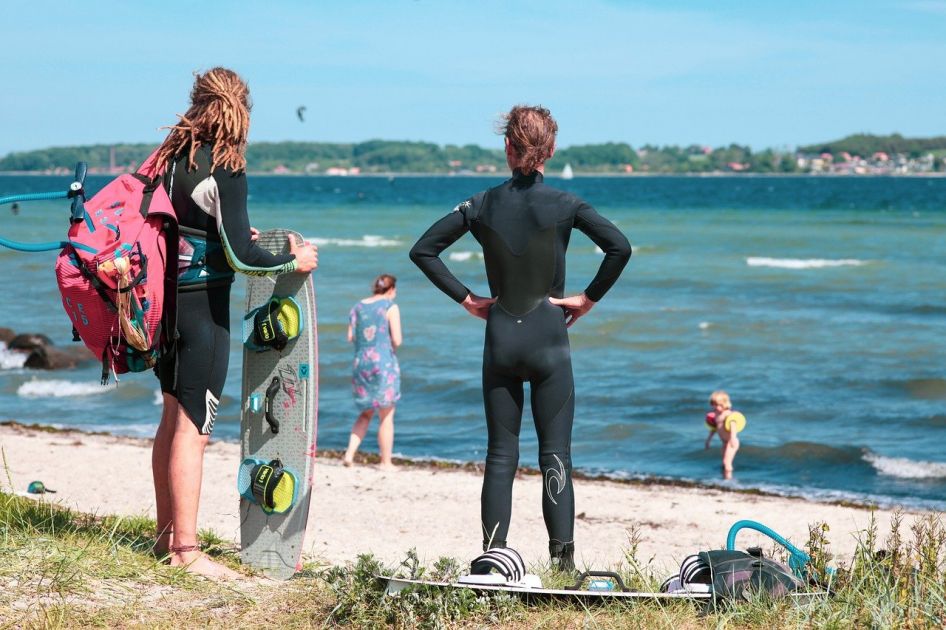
[240,230,319,580]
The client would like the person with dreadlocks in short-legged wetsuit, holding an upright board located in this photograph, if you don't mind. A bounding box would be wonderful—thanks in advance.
[151,68,318,577]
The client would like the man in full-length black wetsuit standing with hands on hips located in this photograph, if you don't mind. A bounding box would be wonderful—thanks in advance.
[410,106,631,570]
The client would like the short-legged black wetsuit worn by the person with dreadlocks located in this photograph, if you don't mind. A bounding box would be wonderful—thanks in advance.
[156,147,295,435]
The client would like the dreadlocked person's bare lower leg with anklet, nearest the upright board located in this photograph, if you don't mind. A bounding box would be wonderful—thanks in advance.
[168,406,240,578]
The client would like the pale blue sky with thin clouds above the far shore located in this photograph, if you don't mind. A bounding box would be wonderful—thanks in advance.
[0,0,946,156]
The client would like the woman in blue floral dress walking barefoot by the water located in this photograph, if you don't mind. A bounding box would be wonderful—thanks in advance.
[345,274,401,470]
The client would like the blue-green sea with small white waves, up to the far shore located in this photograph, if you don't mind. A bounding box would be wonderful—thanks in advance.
[0,176,946,509]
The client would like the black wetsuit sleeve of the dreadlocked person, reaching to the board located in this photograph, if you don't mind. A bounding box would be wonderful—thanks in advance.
[213,169,296,275]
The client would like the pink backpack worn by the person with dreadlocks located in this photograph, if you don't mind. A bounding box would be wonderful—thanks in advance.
[56,152,178,385]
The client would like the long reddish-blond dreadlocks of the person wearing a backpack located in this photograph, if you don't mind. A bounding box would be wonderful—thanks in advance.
[155,67,250,173]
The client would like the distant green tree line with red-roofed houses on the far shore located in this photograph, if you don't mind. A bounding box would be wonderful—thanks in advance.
[0,134,946,174]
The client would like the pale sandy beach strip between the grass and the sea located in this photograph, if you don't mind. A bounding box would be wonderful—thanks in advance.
[0,424,917,572]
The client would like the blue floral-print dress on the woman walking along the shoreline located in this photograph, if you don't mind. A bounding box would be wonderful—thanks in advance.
[349,300,401,411]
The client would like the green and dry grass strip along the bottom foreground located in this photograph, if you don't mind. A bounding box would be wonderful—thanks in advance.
[0,493,946,629]
